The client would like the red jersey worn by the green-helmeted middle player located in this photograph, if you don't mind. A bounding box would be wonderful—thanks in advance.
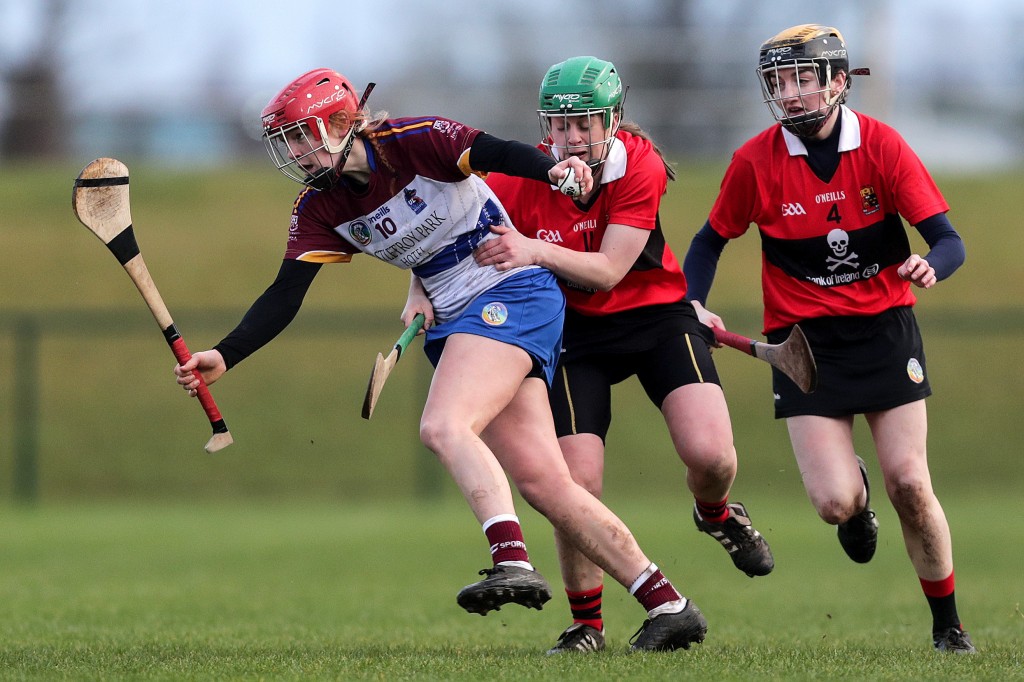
[487,130,686,315]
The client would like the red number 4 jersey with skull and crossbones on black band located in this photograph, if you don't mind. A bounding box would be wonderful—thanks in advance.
[710,106,949,334]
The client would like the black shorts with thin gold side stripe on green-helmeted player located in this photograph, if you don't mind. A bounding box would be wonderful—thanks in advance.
[549,301,720,440]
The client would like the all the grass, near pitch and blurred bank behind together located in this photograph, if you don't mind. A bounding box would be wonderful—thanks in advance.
[0,160,1024,680]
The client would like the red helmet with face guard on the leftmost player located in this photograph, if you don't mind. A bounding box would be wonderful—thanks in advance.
[262,69,374,190]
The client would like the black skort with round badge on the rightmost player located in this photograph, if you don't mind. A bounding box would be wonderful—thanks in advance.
[768,307,932,419]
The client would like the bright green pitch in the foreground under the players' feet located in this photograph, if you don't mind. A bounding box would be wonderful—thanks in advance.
[0,498,1024,680]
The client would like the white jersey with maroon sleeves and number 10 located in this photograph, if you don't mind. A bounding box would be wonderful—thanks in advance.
[285,117,532,324]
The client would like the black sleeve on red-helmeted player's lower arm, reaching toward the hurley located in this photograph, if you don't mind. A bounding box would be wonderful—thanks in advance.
[214,259,321,370]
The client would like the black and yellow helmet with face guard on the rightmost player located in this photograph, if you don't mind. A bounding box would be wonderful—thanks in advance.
[757,24,866,137]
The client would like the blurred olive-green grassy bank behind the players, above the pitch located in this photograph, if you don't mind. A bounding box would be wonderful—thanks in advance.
[0,163,1024,501]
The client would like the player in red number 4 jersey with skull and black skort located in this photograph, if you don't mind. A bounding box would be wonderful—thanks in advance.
[684,25,975,653]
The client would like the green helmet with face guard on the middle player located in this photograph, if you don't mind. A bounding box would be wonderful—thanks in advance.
[537,56,627,167]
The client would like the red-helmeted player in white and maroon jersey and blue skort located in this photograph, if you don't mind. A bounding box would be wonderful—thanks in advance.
[175,69,708,650]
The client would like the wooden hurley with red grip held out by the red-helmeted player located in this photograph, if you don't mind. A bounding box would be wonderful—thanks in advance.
[71,159,232,453]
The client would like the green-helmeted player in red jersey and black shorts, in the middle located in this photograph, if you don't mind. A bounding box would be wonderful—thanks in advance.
[476,56,774,653]
